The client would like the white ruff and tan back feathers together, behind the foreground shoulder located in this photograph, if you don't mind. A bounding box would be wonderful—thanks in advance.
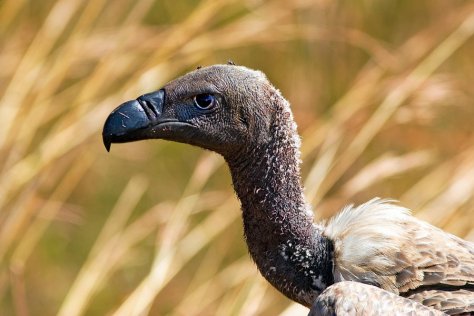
[326,199,474,313]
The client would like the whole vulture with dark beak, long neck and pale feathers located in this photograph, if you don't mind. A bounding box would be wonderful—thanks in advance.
[102,64,474,315]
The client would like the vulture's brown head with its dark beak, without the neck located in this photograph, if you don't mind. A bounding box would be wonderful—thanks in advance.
[103,65,289,158]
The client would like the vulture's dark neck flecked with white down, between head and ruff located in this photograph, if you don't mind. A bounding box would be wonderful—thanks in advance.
[226,105,334,307]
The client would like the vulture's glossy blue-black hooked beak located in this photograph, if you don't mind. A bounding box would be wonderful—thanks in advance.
[102,89,165,151]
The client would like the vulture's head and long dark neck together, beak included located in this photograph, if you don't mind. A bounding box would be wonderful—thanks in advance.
[103,65,322,306]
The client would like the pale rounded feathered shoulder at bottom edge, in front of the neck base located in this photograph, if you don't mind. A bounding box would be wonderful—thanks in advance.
[309,281,445,316]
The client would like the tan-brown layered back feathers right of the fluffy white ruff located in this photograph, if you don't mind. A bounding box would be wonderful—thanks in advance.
[395,220,474,315]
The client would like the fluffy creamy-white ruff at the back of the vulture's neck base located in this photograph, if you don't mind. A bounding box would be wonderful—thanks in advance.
[324,198,414,282]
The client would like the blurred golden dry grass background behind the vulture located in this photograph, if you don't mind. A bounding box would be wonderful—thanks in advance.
[0,0,474,316]
